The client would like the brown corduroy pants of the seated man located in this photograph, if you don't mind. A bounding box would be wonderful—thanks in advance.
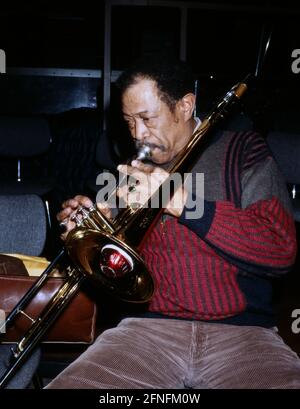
[46,318,300,389]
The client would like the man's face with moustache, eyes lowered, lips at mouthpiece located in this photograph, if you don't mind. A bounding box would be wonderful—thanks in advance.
[122,78,190,164]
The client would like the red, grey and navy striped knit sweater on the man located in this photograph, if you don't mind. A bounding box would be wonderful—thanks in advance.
[141,132,296,326]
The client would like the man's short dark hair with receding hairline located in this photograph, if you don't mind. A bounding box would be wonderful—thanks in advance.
[116,56,195,111]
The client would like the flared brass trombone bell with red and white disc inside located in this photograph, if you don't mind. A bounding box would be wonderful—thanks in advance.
[66,228,154,303]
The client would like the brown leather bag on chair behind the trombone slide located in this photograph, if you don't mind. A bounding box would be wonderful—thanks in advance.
[0,275,96,344]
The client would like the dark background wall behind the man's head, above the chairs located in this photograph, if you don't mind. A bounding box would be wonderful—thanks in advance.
[0,0,300,130]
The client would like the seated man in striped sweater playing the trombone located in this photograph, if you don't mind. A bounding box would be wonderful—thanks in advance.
[48,58,300,388]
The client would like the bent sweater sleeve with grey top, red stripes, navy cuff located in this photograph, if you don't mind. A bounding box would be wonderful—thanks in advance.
[179,157,296,276]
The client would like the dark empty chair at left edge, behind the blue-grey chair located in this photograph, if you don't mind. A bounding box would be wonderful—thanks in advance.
[0,116,54,230]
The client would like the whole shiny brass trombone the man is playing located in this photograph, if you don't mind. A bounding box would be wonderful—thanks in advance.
[0,76,247,388]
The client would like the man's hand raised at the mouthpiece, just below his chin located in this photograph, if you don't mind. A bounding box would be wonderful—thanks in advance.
[118,160,187,217]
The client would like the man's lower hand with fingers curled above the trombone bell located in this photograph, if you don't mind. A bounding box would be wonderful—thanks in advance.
[56,195,111,240]
